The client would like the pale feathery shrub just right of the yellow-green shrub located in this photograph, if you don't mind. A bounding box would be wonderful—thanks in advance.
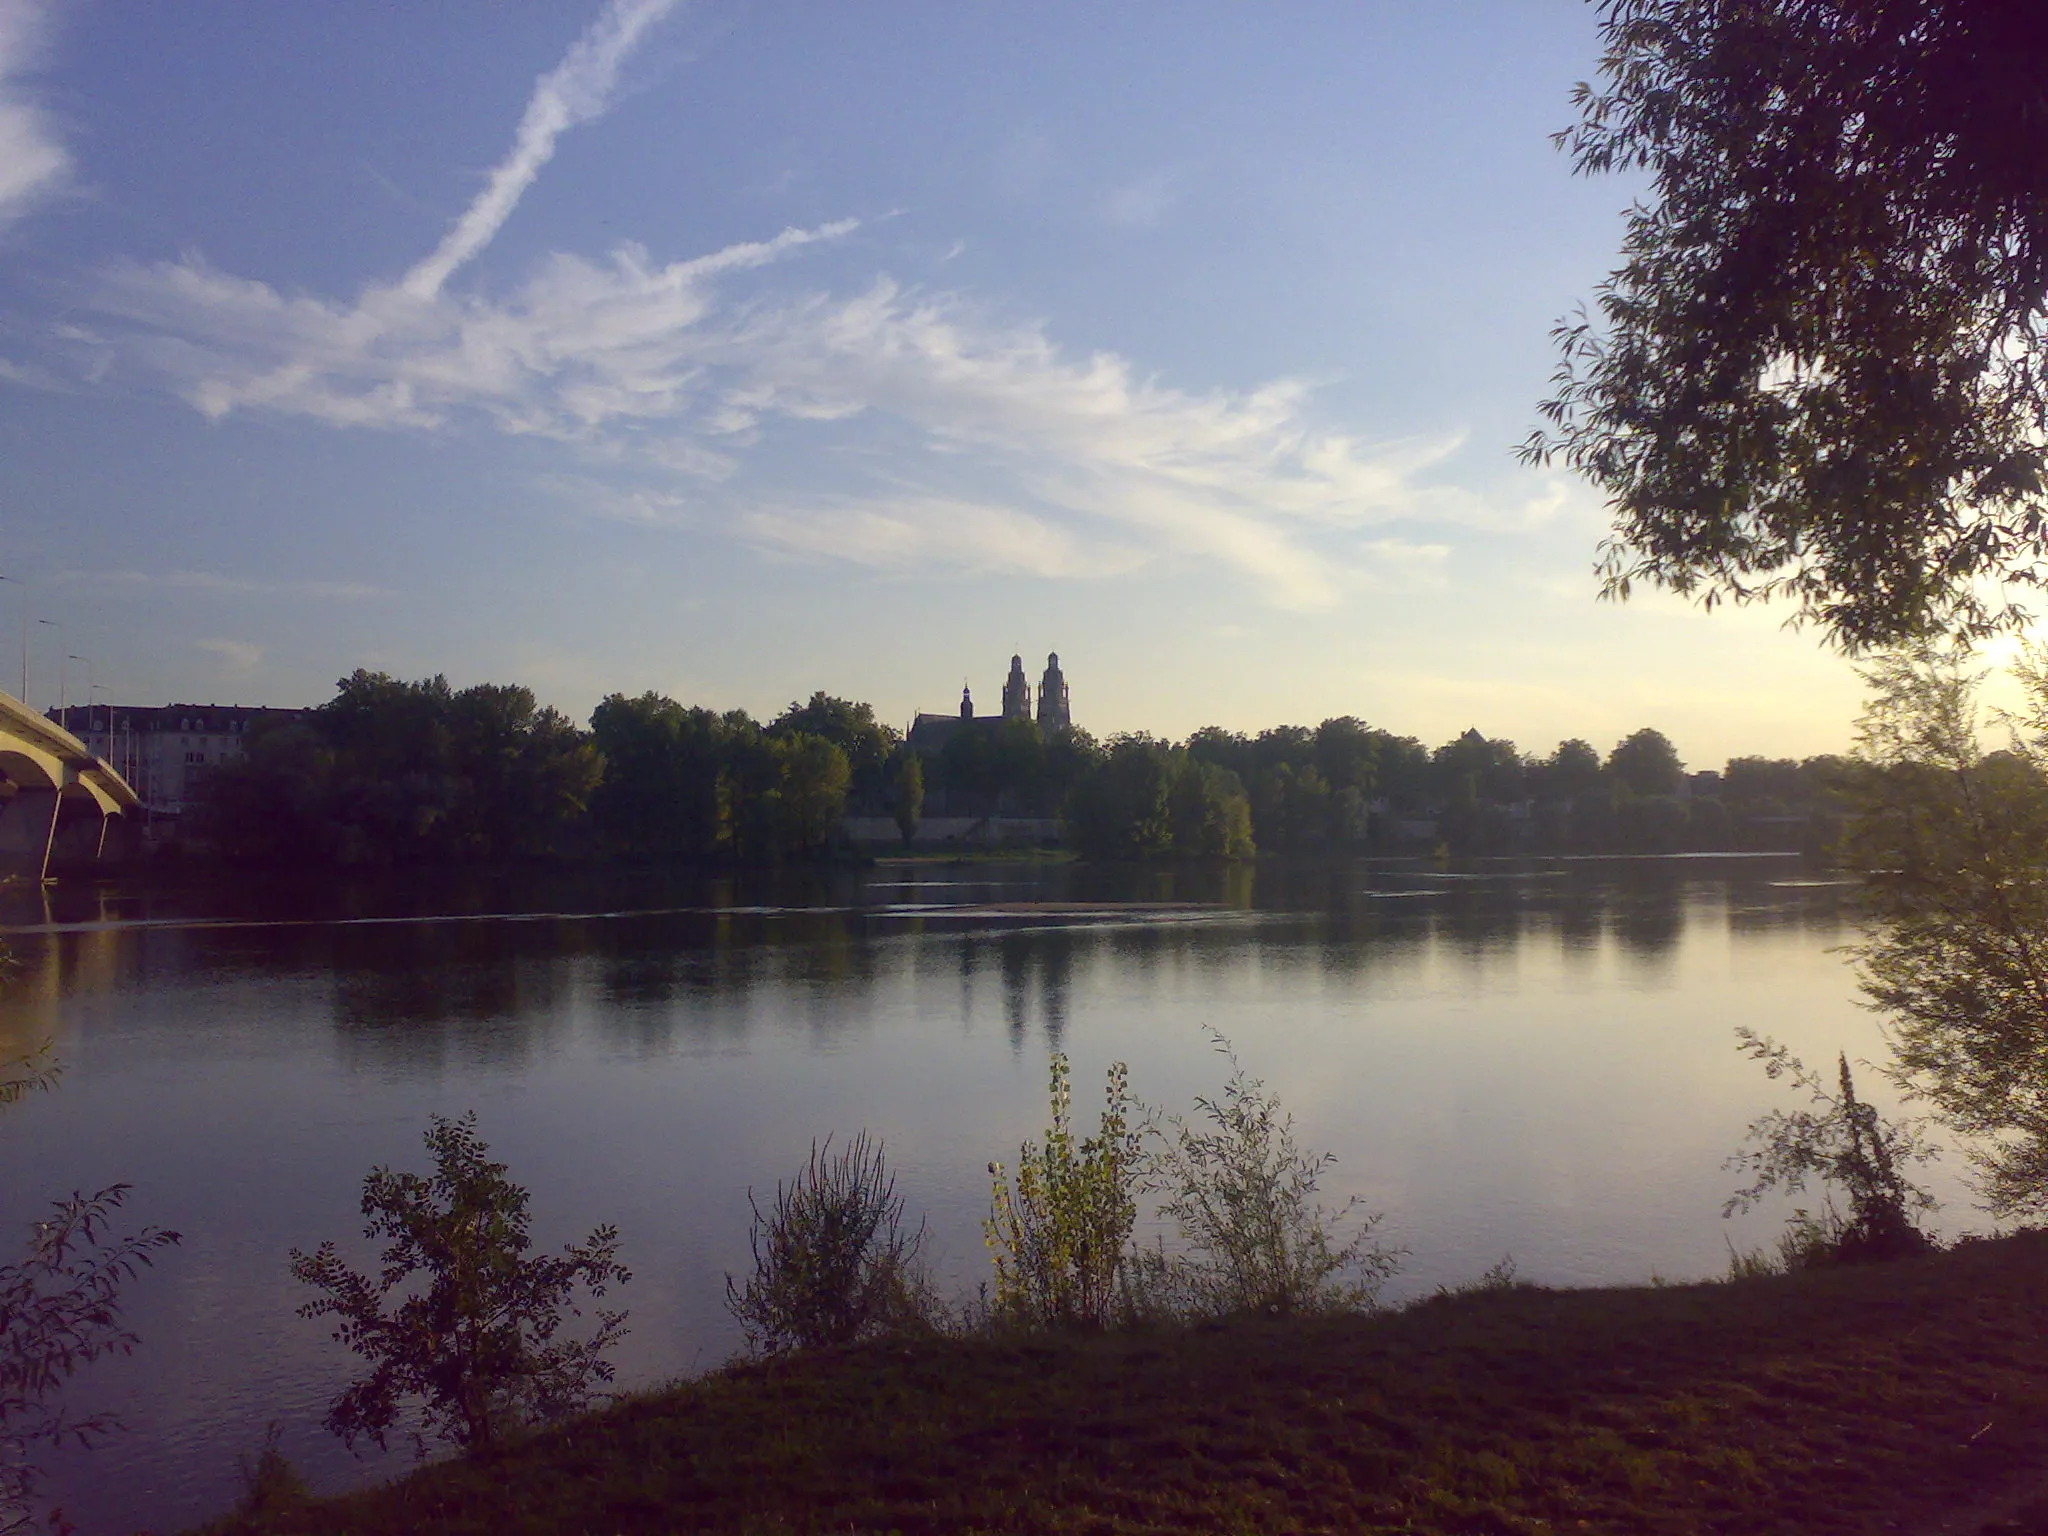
[1145,1034,1399,1317]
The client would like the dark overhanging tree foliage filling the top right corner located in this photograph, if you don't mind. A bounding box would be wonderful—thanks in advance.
[1526,0,2048,647]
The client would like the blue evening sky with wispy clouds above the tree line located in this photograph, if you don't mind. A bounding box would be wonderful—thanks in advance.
[0,0,1862,766]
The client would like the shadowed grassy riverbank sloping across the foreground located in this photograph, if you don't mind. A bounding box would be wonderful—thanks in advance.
[207,1233,2048,1536]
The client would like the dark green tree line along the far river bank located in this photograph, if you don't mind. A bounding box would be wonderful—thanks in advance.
[193,670,1849,864]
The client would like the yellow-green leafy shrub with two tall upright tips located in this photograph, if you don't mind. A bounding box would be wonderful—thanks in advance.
[983,1053,1143,1327]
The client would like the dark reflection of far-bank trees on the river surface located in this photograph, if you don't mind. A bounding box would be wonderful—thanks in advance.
[0,860,1855,1069]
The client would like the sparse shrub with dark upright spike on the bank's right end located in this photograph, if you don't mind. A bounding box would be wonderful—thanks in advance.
[1720,1028,1935,1272]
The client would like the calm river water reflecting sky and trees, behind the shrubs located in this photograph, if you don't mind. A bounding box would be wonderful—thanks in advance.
[0,858,1968,1532]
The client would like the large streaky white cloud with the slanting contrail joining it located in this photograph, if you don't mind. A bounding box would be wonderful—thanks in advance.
[51,0,1532,606]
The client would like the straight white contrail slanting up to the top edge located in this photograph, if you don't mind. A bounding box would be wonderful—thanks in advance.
[399,0,676,299]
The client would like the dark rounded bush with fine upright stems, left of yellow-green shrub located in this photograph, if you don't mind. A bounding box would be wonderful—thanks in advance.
[725,1130,934,1354]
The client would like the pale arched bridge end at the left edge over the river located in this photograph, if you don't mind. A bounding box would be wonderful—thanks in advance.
[0,692,141,885]
